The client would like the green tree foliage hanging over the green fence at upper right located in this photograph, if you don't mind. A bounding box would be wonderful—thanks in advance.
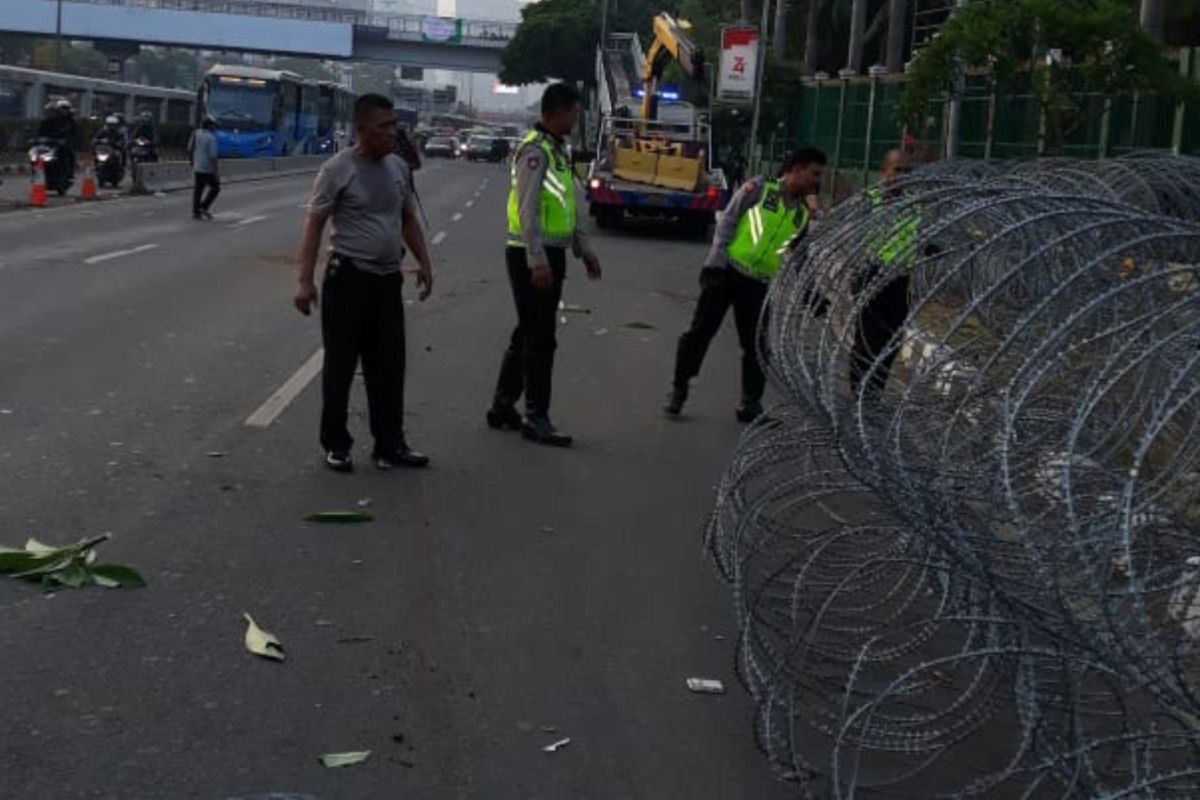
[900,0,1196,150]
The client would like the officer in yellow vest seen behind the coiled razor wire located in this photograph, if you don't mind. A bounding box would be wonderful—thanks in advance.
[850,150,919,393]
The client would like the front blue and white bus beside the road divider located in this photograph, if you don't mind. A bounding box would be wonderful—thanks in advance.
[199,65,320,158]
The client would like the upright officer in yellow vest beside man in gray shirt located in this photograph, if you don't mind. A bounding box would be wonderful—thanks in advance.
[487,84,600,447]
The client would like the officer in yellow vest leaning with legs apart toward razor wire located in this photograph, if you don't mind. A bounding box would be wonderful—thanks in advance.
[664,148,826,422]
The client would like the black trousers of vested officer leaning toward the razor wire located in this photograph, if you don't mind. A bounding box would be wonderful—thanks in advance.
[674,266,767,402]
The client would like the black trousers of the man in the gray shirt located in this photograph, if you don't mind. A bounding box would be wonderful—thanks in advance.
[320,254,404,453]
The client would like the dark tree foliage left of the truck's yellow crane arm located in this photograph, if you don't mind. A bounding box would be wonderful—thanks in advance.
[499,0,600,86]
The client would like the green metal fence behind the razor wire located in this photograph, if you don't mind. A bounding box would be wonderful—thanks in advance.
[758,48,1200,199]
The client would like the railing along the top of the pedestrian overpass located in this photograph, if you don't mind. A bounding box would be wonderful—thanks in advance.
[67,0,517,42]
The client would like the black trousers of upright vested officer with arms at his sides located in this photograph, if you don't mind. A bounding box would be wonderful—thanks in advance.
[493,247,566,417]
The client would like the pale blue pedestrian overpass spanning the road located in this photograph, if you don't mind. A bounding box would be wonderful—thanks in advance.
[0,0,516,72]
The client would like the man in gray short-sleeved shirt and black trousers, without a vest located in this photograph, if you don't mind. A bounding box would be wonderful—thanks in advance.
[295,95,433,473]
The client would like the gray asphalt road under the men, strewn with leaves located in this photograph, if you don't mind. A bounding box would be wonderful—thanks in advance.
[0,162,791,800]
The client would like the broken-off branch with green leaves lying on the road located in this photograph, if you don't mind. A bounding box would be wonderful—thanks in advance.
[0,534,146,591]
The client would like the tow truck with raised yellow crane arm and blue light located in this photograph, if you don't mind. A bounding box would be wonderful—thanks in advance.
[587,13,726,236]
